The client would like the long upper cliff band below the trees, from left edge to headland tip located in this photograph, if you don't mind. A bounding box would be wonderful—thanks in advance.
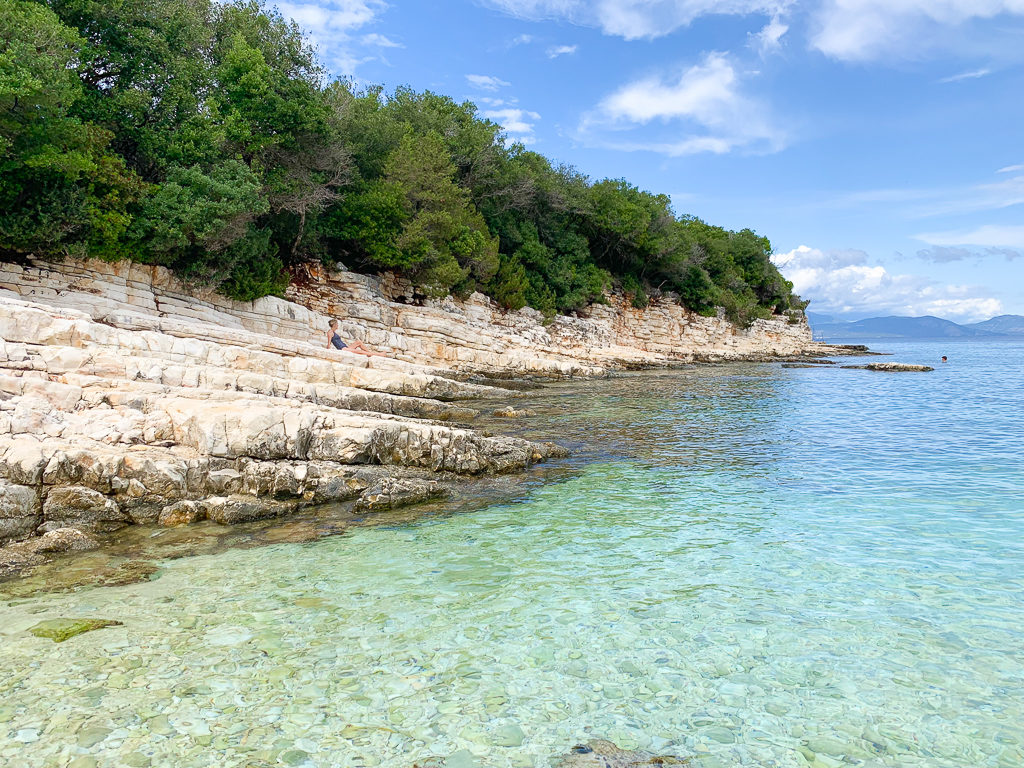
[0,261,812,375]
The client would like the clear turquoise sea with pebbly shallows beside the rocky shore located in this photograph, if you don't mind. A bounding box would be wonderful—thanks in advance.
[0,343,1024,768]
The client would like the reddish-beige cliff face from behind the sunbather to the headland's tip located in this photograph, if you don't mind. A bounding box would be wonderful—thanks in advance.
[288,268,811,374]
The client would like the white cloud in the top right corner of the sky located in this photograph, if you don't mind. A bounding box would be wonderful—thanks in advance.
[811,0,1024,60]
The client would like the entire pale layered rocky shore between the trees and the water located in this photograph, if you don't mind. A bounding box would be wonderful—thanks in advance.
[0,258,826,575]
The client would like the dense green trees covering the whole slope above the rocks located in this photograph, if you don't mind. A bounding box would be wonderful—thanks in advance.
[0,0,801,322]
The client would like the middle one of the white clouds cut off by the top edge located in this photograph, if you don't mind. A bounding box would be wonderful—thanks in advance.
[484,0,792,40]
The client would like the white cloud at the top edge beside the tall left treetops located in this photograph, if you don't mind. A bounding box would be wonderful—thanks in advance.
[276,0,387,75]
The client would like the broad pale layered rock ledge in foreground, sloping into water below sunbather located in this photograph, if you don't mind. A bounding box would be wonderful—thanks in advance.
[0,295,561,574]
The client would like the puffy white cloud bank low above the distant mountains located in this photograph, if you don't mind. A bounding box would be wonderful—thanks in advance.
[772,246,1002,322]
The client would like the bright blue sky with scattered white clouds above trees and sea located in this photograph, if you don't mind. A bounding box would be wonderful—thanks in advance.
[276,0,1024,323]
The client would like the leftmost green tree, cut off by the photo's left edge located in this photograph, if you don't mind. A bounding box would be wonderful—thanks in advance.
[0,0,140,258]
